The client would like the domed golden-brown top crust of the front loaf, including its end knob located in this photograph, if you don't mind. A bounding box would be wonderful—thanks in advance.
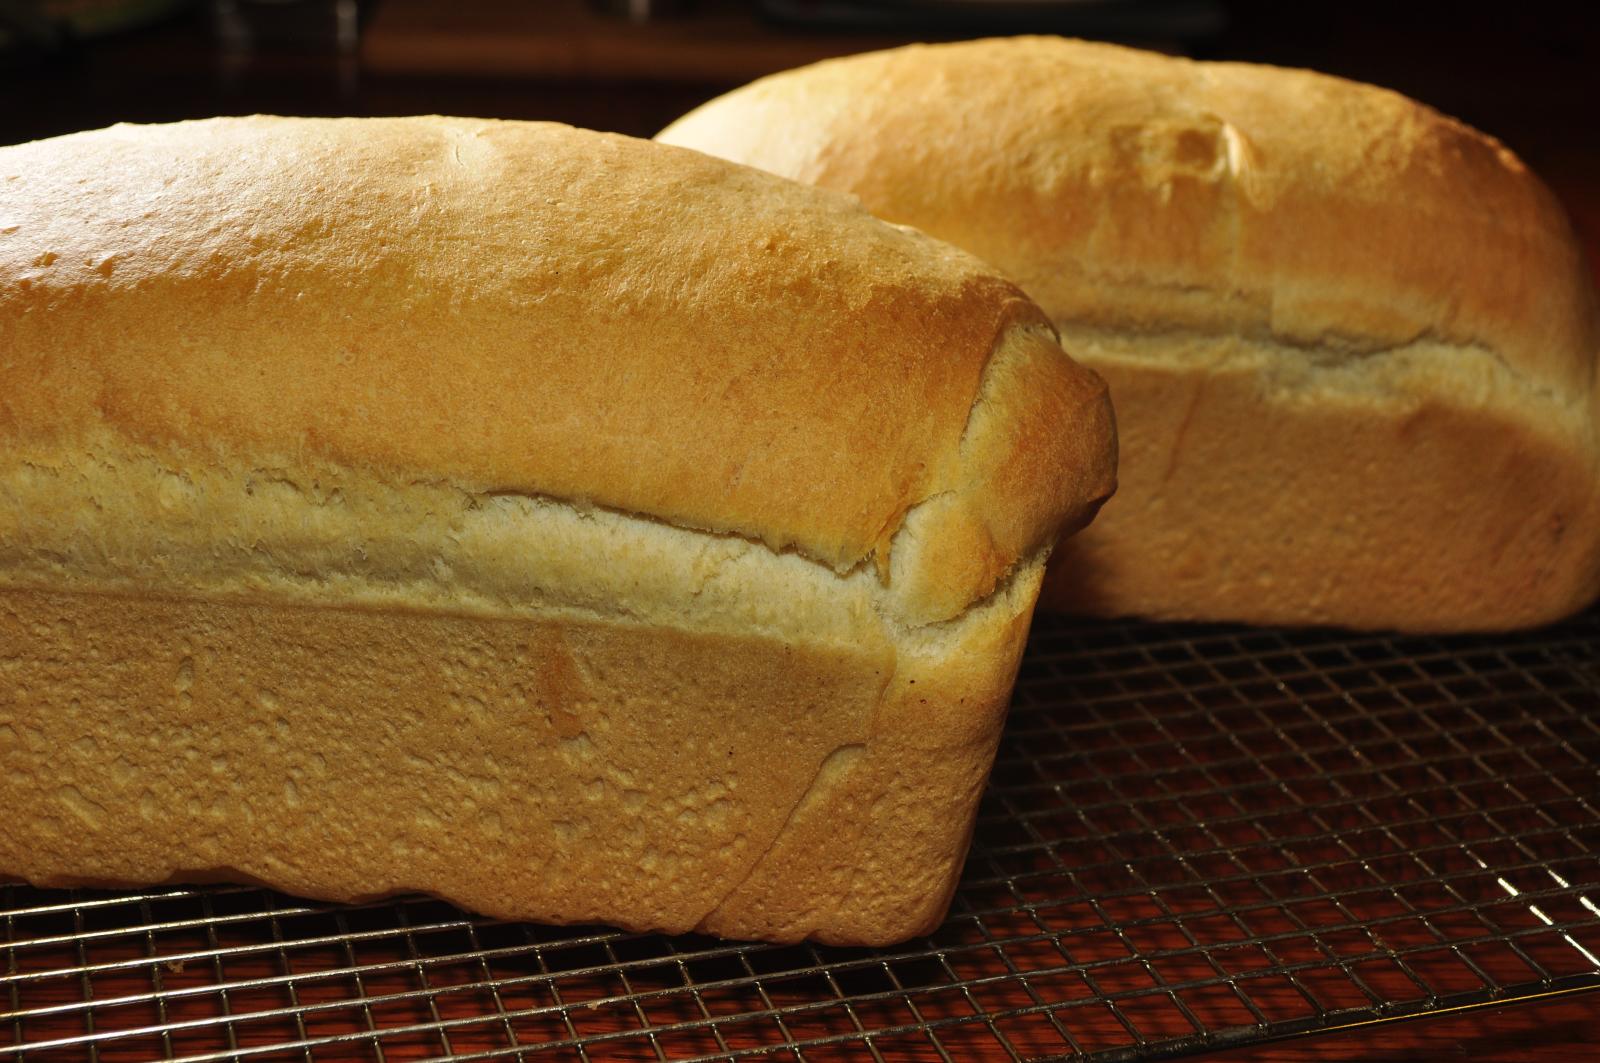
[0,117,1114,624]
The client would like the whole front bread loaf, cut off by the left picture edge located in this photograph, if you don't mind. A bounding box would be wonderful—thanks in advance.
[0,118,1115,943]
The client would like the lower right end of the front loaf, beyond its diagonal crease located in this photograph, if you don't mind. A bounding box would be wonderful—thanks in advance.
[696,551,1046,946]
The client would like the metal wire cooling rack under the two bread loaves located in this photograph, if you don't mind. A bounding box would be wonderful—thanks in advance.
[0,613,1600,1061]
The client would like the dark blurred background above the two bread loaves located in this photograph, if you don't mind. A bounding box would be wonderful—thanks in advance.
[0,0,1600,260]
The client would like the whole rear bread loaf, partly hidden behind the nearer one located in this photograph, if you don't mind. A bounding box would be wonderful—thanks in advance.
[659,38,1600,631]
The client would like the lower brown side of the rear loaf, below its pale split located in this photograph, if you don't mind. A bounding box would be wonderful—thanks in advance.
[1040,335,1600,631]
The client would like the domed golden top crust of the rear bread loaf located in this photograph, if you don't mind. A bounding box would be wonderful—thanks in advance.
[658,37,1600,405]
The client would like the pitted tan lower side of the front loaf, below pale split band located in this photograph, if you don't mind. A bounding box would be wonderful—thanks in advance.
[0,562,1043,945]
